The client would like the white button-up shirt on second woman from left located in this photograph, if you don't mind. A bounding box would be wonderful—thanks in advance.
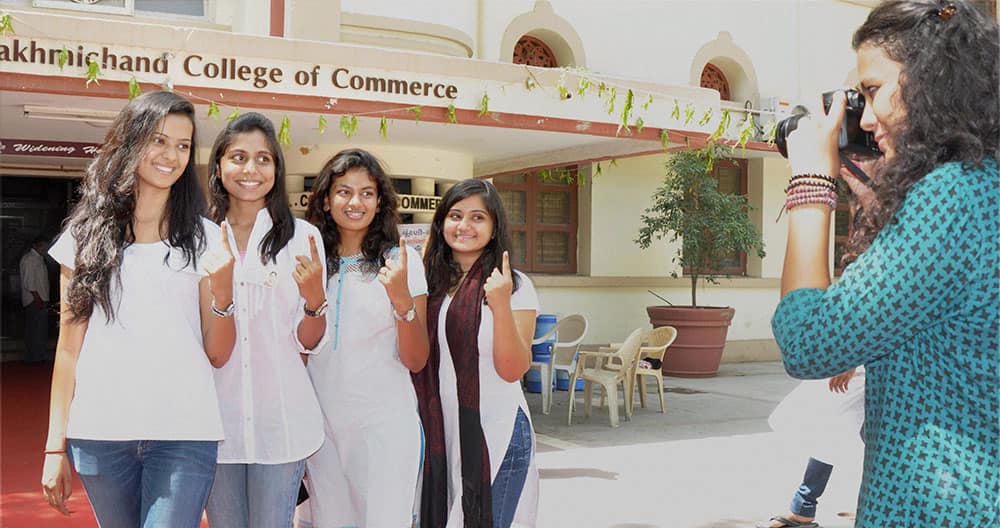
[215,212,327,464]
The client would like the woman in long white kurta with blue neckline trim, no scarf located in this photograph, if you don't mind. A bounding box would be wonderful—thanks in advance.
[298,149,428,528]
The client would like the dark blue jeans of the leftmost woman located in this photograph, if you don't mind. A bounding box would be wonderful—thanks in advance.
[69,439,219,528]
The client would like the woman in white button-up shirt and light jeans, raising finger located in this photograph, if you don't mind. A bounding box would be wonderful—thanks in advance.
[208,113,326,528]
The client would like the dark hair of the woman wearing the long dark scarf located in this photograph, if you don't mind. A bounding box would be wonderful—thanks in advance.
[424,179,520,298]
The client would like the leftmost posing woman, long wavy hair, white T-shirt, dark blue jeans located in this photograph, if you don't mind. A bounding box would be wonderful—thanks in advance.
[42,92,235,528]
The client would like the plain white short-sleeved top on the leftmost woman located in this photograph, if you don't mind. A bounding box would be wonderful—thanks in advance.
[49,218,222,440]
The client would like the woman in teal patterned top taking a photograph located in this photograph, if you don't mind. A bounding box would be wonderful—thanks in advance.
[772,0,1000,527]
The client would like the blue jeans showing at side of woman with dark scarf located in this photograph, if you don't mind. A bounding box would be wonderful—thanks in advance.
[493,408,532,528]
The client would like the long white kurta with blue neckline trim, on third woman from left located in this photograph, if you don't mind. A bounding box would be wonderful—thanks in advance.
[306,248,427,528]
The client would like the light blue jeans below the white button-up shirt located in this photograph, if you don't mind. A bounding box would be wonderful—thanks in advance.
[208,459,306,528]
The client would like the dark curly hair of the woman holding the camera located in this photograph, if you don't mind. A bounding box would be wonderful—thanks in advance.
[844,0,1000,264]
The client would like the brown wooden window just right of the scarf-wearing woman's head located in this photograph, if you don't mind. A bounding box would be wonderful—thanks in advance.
[493,167,577,273]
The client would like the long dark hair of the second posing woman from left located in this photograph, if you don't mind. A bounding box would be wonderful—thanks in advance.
[208,112,295,264]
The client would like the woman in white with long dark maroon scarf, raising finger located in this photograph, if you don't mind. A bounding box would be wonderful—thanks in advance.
[414,180,538,528]
